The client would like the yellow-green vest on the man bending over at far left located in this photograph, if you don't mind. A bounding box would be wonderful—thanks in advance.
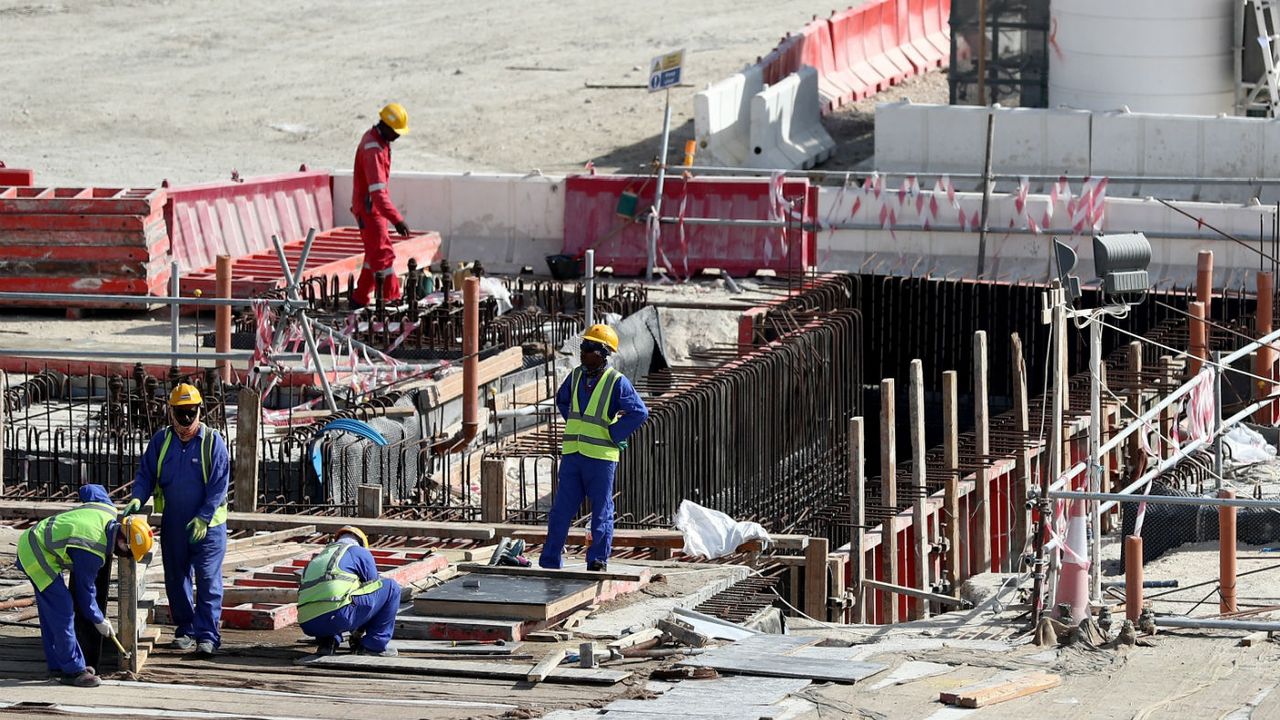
[18,502,119,592]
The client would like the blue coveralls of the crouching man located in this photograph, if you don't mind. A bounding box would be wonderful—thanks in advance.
[302,537,401,652]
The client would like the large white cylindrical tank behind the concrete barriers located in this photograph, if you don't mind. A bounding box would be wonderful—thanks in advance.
[1048,0,1238,115]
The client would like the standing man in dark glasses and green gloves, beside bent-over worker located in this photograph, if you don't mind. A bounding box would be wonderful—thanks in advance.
[124,383,230,655]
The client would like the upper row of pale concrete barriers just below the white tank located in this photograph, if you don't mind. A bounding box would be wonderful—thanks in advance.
[874,101,1280,202]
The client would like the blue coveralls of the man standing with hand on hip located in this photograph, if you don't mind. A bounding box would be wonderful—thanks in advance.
[538,363,649,569]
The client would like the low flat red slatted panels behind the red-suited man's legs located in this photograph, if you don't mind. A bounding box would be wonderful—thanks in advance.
[182,227,440,297]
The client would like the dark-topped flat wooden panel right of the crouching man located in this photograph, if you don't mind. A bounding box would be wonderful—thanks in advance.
[413,575,602,620]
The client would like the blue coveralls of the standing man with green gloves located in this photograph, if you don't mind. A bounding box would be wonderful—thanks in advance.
[133,423,230,647]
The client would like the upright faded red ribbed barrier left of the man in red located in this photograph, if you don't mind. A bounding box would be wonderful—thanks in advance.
[164,170,333,273]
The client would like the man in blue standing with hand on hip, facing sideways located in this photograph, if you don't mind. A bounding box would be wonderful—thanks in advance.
[538,324,649,570]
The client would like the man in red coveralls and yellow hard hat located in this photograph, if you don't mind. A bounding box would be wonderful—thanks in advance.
[351,102,408,307]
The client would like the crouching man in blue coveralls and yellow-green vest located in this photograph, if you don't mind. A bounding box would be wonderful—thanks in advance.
[298,525,401,657]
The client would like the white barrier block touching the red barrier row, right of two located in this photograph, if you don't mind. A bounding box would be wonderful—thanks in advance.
[746,65,836,169]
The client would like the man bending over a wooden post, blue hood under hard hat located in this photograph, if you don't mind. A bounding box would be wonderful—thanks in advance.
[18,486,152,688]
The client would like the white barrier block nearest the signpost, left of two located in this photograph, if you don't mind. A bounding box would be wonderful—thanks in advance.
[694,64,764,168]
